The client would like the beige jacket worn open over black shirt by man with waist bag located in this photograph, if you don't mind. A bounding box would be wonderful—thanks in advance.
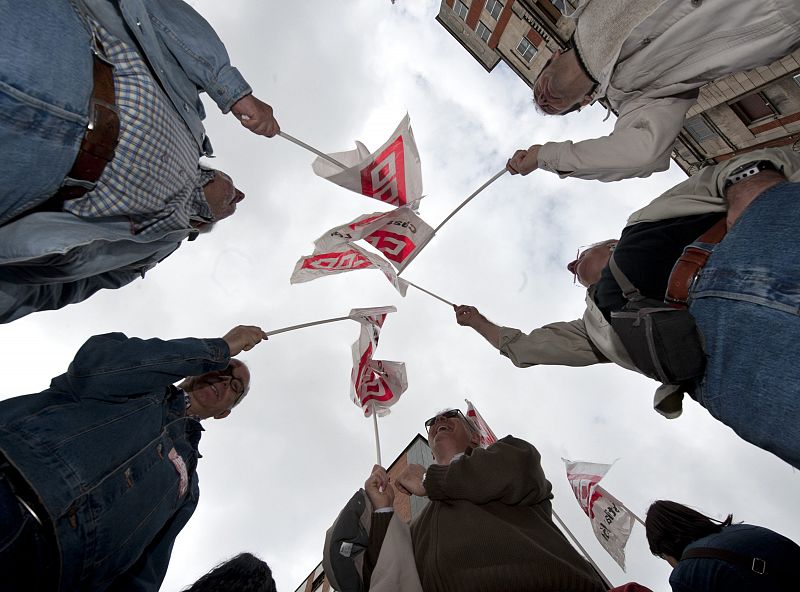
[497,146,800,419]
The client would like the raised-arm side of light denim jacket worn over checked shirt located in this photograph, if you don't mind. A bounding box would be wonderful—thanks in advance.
[77,0,252,155]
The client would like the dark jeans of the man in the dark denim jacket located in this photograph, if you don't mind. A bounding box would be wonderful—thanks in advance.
[0,466,55,592]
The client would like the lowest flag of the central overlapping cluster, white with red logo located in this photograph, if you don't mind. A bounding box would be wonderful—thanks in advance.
[289,243,408,296]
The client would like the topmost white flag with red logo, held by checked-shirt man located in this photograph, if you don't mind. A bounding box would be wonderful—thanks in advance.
[311,114,422,206]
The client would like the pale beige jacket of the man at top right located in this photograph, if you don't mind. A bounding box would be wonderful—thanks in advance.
[539,0,800,181]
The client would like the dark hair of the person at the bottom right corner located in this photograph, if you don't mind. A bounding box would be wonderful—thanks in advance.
[644,500,733,561]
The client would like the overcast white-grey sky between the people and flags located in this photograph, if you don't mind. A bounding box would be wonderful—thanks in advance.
[2,0,800,592]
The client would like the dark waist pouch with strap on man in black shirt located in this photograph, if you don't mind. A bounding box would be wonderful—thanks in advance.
[608,254,706,385]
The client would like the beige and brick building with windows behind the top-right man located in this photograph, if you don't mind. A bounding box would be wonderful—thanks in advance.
[436,0,800,174]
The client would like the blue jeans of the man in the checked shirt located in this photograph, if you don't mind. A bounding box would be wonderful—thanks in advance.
[0,0,92,224]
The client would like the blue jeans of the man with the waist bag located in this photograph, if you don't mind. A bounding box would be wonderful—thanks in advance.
[690,183,800,468]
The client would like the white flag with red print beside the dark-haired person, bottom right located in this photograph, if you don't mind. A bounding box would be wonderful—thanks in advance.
[561,458,634,571]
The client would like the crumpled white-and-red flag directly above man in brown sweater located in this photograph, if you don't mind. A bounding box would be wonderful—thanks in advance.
[348,306,408,417]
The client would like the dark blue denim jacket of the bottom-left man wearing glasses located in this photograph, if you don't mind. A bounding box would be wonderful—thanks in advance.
[0,333,230,591]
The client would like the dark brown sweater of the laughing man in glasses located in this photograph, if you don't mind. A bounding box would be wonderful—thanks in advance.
[367,436,605,592]
